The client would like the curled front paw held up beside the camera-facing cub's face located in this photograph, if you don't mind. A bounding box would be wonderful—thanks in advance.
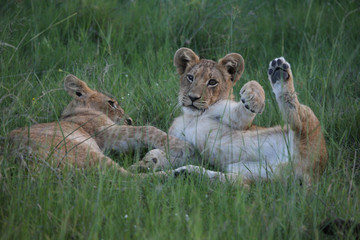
[240,81,265,113]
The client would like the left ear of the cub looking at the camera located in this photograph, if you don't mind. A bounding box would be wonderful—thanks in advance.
[174,48,200,75]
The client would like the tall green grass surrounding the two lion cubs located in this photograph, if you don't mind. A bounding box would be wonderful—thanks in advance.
[0,0,360,239]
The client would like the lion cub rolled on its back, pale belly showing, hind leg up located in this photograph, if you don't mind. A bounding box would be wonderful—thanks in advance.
[139,48,327,183]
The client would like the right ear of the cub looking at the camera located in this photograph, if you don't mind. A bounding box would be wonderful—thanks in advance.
[219,53,245,83]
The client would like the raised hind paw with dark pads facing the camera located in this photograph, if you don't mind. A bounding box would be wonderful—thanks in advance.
[268,57,291,84]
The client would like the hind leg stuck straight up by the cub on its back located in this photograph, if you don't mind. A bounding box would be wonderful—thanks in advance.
[268,57,327,181]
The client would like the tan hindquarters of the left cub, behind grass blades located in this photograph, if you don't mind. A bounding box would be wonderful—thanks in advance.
[10,121,101,168]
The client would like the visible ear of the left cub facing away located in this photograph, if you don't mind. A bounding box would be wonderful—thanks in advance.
[64,74,93,98]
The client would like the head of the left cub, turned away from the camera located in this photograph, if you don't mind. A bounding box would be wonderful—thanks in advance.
[61,74,133,125]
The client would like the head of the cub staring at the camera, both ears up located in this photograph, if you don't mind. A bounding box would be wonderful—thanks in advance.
[174,48,244,113]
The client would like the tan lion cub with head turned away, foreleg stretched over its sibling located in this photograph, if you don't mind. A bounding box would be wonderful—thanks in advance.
[10,75,188,174]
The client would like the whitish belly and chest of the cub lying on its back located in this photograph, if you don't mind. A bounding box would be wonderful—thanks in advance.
[170,115,296,178]
